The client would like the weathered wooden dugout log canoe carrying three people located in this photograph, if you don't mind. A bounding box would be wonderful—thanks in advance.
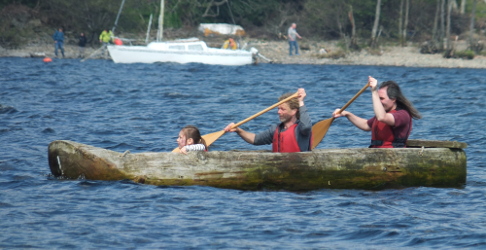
[48,140,467,191]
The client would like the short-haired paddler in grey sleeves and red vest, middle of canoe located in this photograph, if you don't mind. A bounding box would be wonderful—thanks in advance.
[224,88,312,153]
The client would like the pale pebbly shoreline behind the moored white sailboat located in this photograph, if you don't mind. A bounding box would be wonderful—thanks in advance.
[0,39,486,69]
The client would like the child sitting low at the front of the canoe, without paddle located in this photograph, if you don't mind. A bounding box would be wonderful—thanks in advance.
[177,125,207,154]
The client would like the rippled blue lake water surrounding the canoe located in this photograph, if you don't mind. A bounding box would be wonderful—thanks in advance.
[0,58,486,249]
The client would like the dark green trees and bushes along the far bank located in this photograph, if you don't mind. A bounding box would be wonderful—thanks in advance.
[0,0,486,49]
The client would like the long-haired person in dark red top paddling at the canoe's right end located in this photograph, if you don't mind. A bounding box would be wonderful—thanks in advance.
[332,76,422,148]
